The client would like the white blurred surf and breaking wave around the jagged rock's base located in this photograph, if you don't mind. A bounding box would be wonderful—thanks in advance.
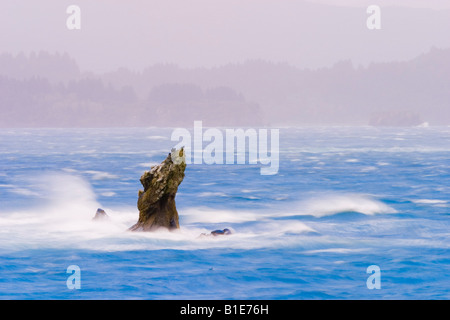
[0,173,395,251]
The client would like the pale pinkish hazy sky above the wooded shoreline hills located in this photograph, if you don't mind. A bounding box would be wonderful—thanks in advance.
[0,0,450,72]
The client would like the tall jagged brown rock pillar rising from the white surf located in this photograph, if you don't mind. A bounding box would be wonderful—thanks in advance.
[130,148,186,231]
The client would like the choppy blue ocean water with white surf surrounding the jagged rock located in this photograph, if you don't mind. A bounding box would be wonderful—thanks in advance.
[0,127,450,299]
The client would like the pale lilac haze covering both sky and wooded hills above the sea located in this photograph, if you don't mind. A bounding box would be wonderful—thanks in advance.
[0,0,450,127]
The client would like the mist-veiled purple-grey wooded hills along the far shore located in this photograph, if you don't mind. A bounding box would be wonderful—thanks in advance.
[0,48,450,127]
